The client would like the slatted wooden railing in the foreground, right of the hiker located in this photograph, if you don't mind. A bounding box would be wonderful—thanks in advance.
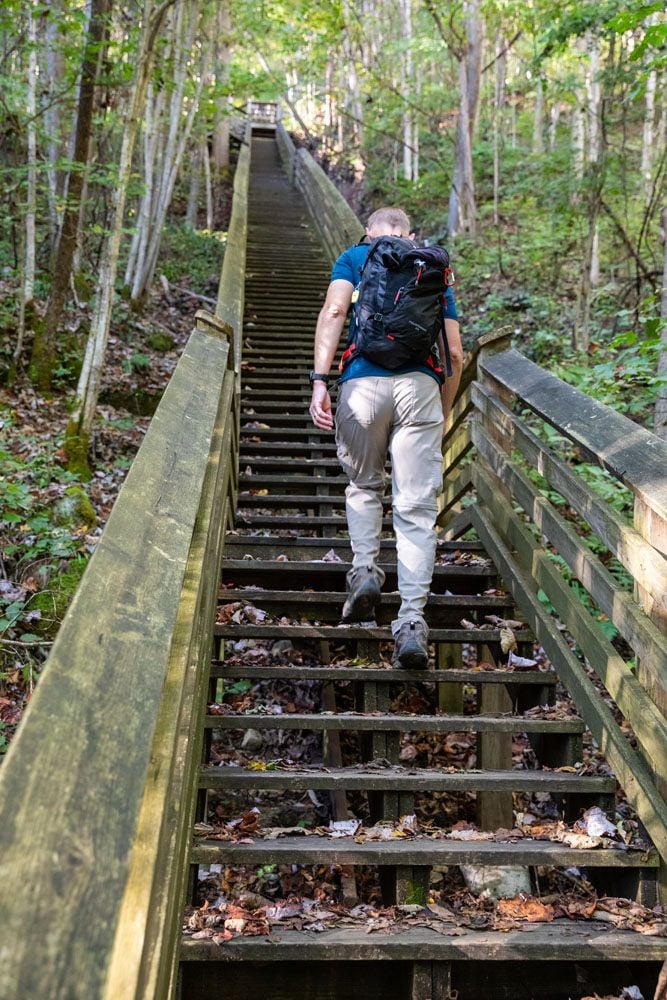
[439,334,667,884]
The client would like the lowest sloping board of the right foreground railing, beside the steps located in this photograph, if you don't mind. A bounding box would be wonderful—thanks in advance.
[473,504,667,858]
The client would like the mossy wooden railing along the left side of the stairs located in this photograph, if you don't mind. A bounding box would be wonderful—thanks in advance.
[0,127,250,1000]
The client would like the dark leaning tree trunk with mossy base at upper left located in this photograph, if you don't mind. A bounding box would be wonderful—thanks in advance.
[30,0,108,392]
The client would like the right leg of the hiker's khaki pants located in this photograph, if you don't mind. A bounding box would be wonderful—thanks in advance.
[389,372,443,634]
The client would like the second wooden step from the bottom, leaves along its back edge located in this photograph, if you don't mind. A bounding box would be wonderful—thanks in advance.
[192,835,659,869]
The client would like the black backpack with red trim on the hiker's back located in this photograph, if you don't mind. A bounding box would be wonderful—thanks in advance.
[341,236,454,376]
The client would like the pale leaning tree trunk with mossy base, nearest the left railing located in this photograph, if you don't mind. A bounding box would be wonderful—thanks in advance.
[65,0,177,475]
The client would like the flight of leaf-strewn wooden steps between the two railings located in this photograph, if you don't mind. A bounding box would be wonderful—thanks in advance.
[180,135,665,1000]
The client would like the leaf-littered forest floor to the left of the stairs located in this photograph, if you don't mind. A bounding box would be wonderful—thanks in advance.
[0,219,223,754]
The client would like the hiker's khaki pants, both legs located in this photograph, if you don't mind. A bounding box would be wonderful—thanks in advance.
[336,372,443,635]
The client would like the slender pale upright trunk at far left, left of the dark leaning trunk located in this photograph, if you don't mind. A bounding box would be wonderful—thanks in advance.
[14,2,37,363]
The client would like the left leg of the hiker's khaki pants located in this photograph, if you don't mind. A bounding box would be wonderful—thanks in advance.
[336,377,394,584]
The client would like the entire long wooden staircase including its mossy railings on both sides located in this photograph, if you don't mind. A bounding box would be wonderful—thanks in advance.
[0,109,667,1000]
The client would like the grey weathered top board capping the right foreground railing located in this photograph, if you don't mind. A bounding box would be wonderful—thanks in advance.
[479,349,667,552]
